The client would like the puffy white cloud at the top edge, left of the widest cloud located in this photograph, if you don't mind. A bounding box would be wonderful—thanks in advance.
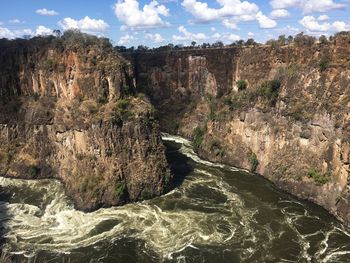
[113,0,170,28]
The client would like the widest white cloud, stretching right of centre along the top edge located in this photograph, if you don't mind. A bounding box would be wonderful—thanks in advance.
[181,0,276,29]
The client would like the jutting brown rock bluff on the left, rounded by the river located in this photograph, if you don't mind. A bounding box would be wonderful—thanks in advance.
[0,34,171,210]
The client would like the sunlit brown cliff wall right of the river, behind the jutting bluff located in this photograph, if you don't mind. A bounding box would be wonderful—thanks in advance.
[134,36,350,228]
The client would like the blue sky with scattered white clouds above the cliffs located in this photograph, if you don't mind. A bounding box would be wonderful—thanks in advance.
[0,0,350,47]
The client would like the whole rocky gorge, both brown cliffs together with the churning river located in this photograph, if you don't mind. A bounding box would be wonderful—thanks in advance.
[0,31,350,262]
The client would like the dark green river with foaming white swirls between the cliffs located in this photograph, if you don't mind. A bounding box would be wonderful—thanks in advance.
[0,134,350,263]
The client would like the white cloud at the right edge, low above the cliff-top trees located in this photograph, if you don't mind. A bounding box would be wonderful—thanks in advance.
[299,16,350,32]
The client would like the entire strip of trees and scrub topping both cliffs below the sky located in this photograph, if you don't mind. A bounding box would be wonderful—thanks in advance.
[0,29,350,53]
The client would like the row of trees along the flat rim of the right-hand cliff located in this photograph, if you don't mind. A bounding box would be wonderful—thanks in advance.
[115,31,350,53]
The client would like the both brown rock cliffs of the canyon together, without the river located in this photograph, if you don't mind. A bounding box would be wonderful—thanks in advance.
[0,31,350,230]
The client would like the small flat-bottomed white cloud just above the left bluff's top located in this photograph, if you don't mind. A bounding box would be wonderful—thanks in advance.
[58,16,109,33]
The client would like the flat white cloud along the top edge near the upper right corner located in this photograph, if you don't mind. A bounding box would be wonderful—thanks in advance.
[270,0,345,14]
